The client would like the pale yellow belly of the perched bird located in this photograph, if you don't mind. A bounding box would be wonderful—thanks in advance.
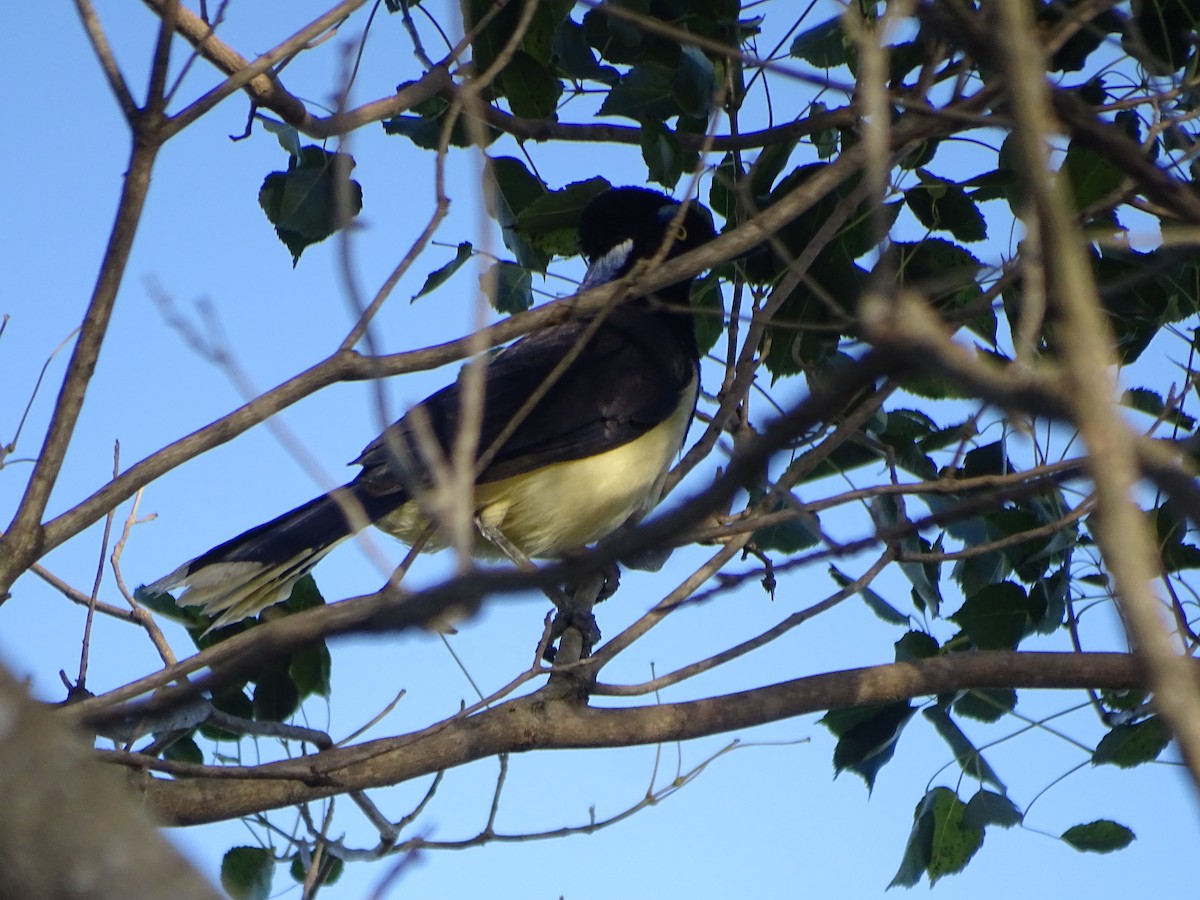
[377,404,691,559]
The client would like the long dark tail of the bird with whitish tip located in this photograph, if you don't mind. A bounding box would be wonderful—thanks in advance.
[146,484,398,630]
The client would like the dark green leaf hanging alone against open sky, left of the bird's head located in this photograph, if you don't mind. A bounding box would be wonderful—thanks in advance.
[258,146,362,265]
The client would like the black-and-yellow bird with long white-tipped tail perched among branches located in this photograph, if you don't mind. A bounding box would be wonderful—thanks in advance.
[146,187,715,631]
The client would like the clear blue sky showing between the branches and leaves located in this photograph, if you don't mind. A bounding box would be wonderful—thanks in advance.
[0,0,1200,900]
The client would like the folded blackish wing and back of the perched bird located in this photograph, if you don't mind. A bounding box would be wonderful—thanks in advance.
[355,307,697,494]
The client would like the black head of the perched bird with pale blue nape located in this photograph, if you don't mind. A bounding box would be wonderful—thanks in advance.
[580,187,716,288]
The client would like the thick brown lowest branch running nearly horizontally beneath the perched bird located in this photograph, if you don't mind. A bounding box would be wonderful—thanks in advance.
[129,650,1144,826]
